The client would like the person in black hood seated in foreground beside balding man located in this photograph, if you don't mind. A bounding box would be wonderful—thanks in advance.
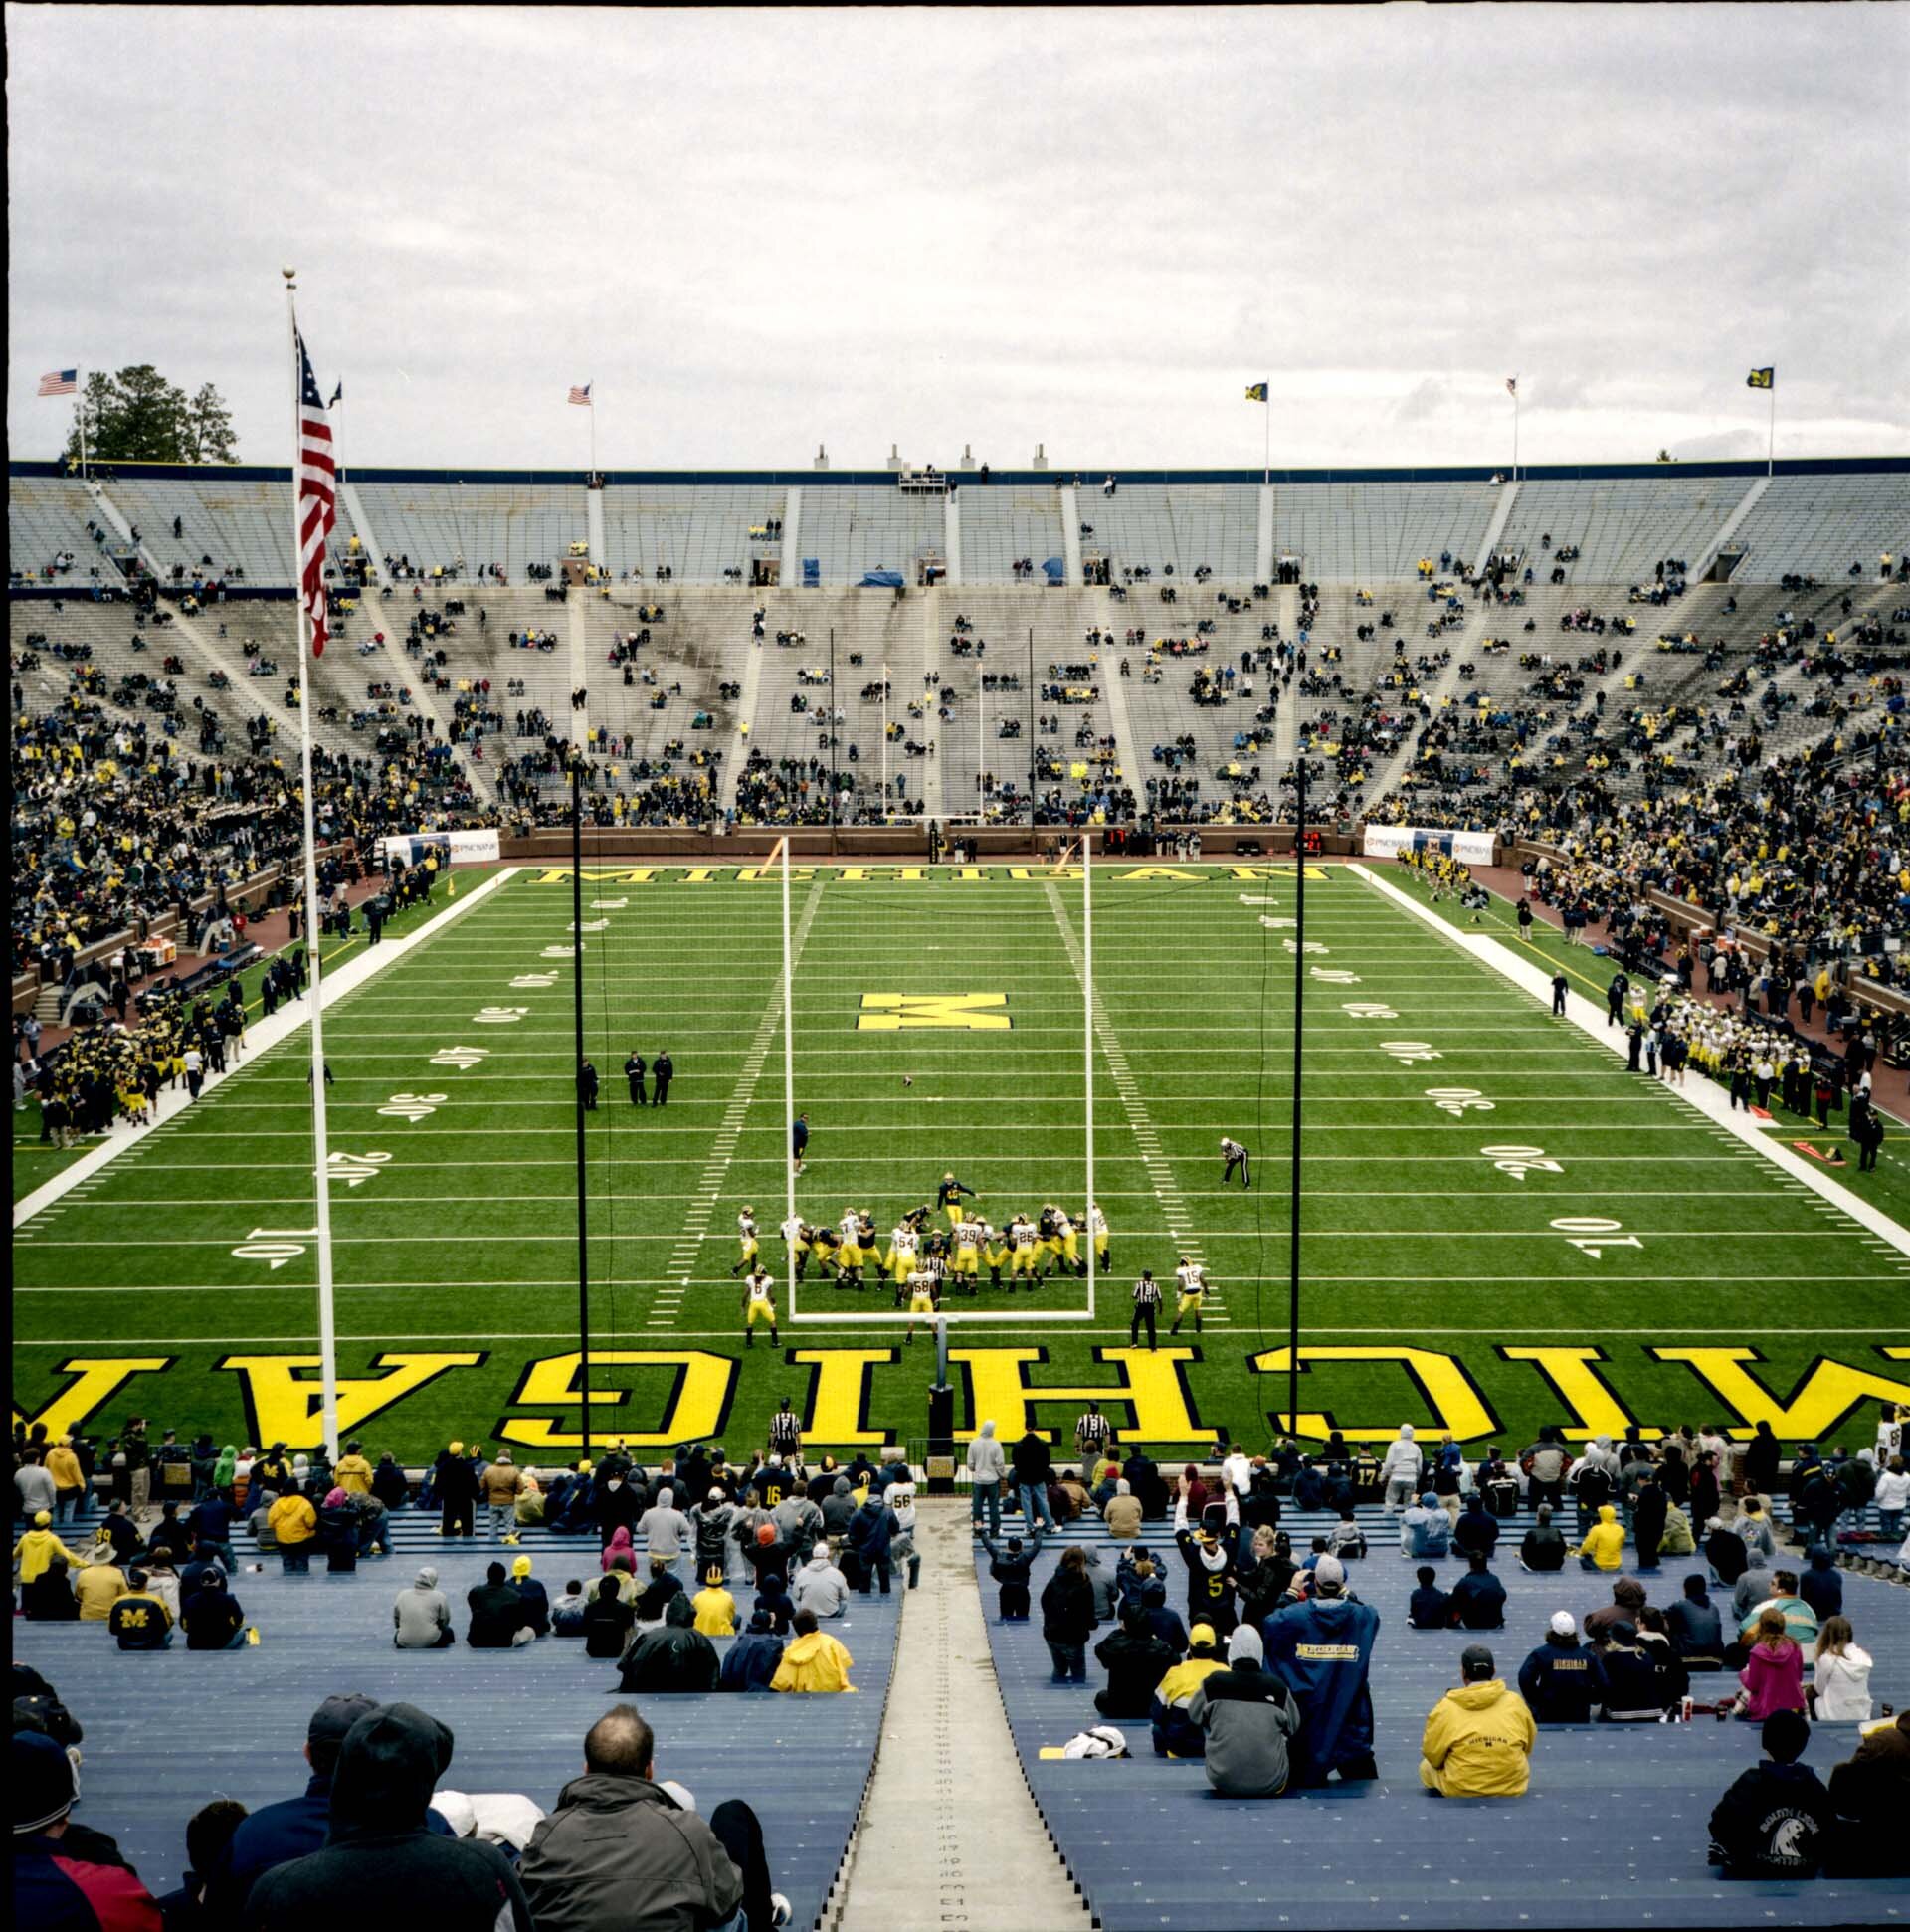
[234,1704,531,1932]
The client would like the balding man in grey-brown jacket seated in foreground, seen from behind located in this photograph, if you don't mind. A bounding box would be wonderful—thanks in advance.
[517,1704,790,1932]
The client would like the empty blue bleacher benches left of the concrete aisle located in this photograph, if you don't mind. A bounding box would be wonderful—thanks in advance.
[14,1513,902,1928]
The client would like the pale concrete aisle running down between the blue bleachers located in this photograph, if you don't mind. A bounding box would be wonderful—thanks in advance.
[833,1497,1091,1932]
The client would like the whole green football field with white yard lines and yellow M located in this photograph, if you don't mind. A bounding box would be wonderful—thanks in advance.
[14,864,1910,1460]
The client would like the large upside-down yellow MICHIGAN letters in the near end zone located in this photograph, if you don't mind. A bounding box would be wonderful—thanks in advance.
[14,1341,1910,1450]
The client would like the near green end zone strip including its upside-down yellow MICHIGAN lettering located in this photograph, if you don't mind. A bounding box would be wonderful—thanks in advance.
[14,1341,1910,1462]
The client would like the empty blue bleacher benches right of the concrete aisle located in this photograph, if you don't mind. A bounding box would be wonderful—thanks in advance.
[977,1507,1910,1932]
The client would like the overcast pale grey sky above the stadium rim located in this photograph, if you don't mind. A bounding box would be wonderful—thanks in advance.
[6,4,1910,468]
